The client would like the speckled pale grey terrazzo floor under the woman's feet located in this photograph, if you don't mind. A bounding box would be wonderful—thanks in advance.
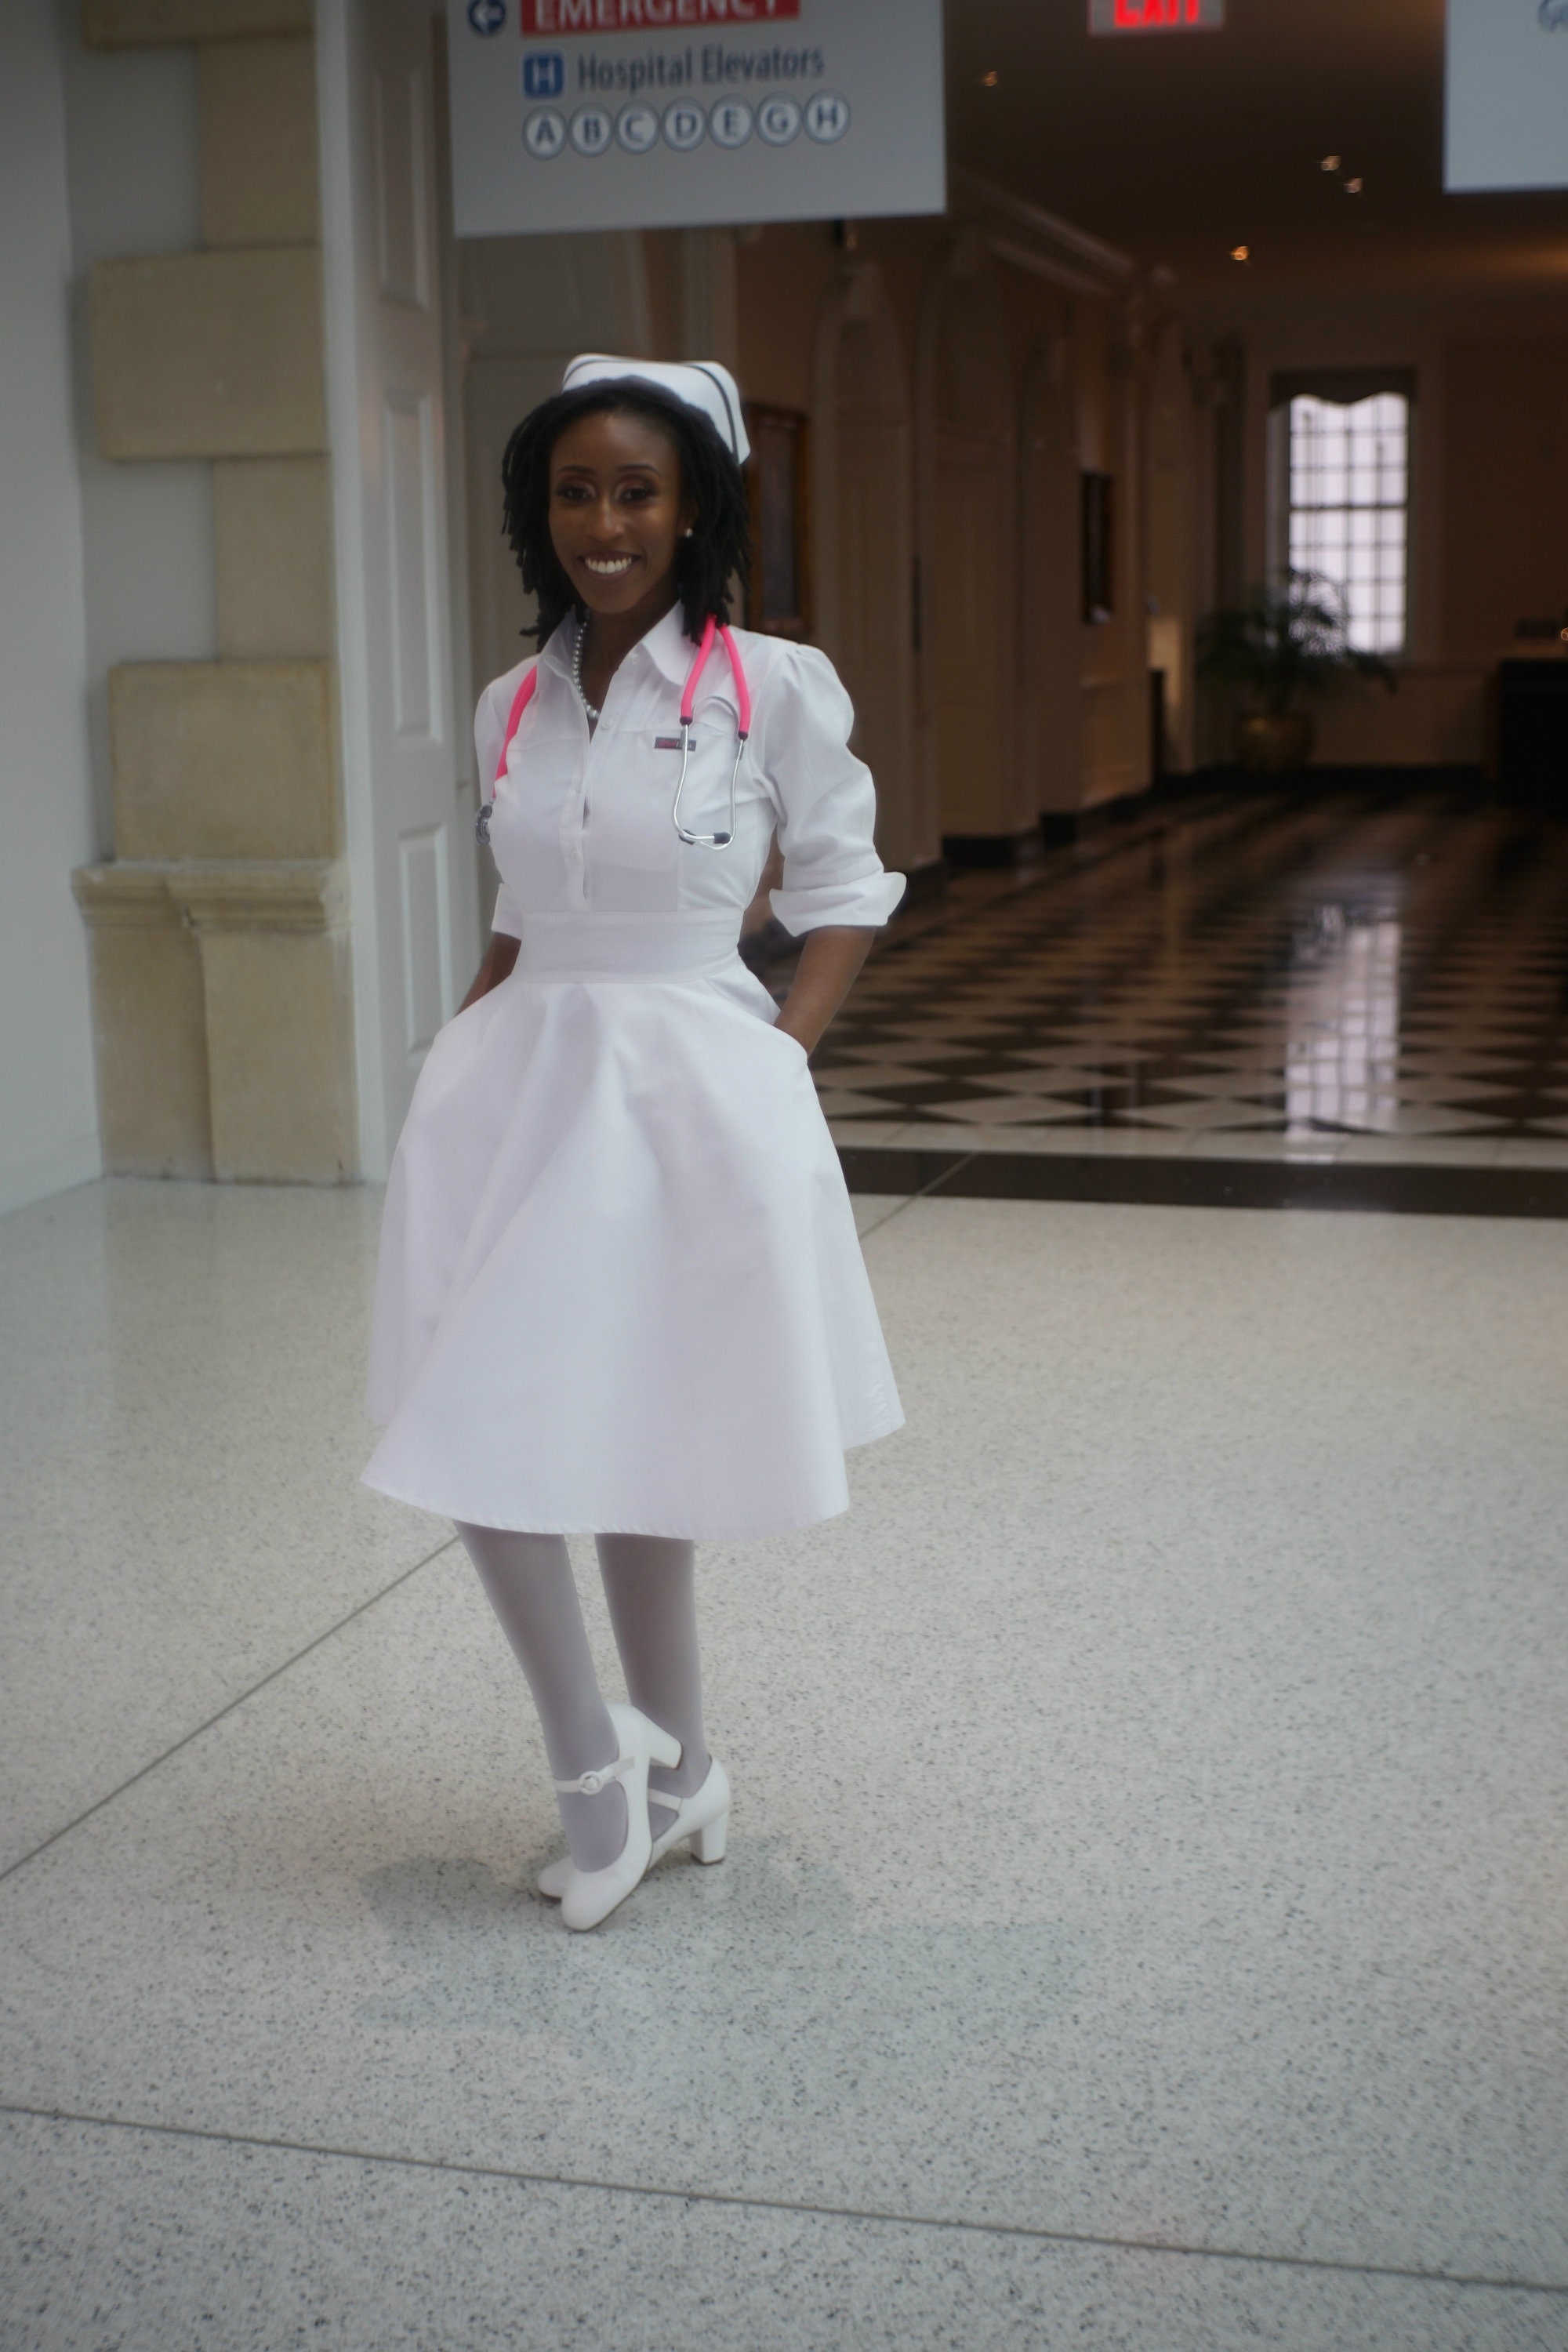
[0,1183,1568,2352]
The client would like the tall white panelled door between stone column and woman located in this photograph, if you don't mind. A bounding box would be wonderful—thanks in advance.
[318,0,477,1178]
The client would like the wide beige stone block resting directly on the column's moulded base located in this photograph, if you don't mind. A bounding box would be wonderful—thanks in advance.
[108,661,339,858]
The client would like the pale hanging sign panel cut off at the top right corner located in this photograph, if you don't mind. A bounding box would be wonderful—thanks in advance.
[1443,0,1568,195]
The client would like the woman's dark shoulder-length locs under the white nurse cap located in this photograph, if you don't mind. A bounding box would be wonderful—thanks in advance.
[501,383,753,647]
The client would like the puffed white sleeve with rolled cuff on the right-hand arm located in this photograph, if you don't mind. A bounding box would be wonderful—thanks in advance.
[755,644,902,938]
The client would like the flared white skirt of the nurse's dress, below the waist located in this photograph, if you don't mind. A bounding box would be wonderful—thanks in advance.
[365,915,902,1538]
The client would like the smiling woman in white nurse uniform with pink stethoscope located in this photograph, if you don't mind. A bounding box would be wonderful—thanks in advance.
[365,358,902,1929]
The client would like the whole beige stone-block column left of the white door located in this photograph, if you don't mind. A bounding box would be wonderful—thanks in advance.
[78,0,355,1183]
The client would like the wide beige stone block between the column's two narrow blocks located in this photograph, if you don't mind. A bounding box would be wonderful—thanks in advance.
[92,245,327,459]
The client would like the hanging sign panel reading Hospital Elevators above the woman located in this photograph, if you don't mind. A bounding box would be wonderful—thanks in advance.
[449,0,947,238]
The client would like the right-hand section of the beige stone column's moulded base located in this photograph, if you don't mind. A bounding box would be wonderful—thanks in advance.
[179,866,358,1183]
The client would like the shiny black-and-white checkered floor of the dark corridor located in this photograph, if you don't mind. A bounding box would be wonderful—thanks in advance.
[815,793,1568,1169]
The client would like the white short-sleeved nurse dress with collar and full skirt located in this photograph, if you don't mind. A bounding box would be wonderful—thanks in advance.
[365,609,902,1538]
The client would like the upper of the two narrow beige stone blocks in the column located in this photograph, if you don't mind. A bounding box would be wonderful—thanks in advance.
[200,40,322,245]
